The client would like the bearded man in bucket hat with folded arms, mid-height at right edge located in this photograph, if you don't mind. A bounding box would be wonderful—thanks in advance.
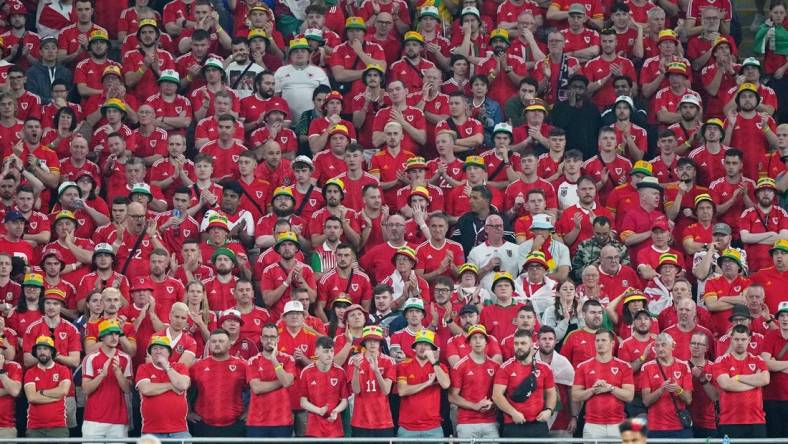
[739,177,788,270]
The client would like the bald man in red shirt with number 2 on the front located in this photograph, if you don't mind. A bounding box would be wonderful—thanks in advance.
[107,202,167,279]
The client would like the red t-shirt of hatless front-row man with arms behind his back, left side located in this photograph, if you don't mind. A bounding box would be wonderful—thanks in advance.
[189,356,246,427]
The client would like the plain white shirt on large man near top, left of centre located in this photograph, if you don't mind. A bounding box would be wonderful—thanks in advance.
[274,65,329,120]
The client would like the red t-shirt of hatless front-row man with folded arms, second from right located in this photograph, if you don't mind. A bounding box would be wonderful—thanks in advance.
[712,353,769,425]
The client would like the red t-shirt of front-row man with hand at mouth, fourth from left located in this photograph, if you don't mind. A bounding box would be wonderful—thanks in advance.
[135,362,189,433]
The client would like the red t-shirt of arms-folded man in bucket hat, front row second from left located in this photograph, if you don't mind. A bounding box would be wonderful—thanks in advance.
[23,362,73,429]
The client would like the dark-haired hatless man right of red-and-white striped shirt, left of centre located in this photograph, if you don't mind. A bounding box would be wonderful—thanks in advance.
[315,243,372,322]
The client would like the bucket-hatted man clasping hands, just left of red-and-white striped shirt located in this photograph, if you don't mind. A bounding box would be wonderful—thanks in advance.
[260,232,317,319]
